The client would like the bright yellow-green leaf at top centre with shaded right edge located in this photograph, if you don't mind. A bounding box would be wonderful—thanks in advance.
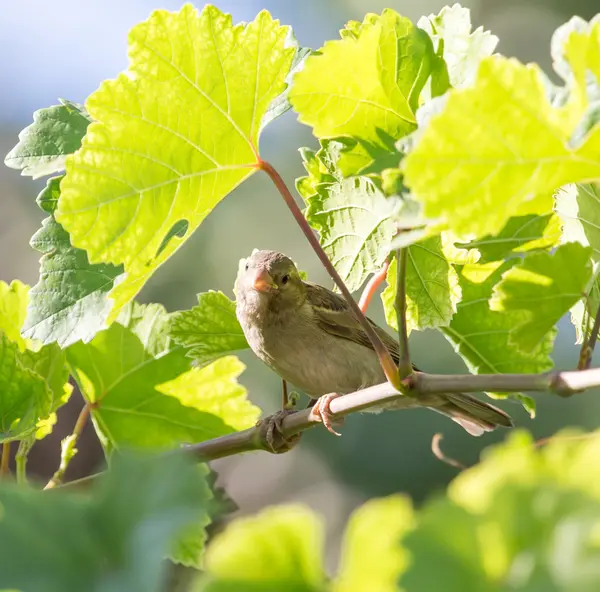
[290,9,434,176]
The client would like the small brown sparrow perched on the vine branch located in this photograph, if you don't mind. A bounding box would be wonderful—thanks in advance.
[234,249,513,436]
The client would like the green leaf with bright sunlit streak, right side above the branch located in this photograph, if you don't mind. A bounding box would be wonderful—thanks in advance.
[490,243,592,352]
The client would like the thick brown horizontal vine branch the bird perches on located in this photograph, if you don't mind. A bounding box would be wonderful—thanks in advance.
[57,368,600,489]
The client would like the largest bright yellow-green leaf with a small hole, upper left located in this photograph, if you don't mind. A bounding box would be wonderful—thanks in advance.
[56,4,297,322]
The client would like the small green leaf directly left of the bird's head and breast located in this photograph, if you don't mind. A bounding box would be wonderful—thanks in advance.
[169,291,249,364]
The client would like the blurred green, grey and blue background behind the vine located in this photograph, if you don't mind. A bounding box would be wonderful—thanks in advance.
[0,0,600,560]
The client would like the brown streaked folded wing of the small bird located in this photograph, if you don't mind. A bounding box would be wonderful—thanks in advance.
[304,282,399,363]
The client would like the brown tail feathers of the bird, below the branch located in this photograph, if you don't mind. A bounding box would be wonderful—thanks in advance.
[432,393,514,436]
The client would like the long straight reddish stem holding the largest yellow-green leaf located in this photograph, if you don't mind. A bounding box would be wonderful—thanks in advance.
[257,160,403,389]
